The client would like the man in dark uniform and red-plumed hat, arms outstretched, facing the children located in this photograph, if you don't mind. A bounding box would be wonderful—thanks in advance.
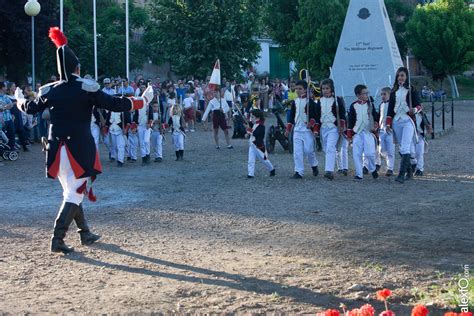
[15,27,147,253]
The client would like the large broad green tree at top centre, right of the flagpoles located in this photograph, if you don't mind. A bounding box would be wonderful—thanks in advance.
[147,0,260,78]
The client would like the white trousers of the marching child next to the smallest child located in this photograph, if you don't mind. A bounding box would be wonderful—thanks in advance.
[293,130,318,175]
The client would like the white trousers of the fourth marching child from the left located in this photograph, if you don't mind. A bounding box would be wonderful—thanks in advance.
[352,131,375,178]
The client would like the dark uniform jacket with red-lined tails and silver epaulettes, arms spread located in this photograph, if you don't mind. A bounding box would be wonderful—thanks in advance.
[22,76,132,179]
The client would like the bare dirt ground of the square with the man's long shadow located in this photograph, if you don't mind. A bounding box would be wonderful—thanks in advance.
[0,104,474,315]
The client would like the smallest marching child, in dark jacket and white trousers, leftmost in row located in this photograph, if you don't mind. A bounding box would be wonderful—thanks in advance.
[246,109,275,179]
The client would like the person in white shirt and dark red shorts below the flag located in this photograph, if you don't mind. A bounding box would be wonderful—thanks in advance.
[202,90,234,149]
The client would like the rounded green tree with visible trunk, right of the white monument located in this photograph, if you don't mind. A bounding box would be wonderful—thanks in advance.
[407,0,474,97]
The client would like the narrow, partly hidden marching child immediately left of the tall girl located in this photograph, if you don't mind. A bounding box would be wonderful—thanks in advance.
[377,87,395,177]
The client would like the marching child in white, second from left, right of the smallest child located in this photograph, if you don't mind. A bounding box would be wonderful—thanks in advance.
[285,80,319,179]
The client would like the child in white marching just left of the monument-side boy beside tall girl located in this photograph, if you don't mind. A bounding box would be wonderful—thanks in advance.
[347,85,379,180]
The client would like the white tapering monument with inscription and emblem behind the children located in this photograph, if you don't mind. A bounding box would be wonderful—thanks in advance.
[332,0,403,103]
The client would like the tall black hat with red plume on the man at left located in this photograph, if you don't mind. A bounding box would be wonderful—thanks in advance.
[49,27,79,82]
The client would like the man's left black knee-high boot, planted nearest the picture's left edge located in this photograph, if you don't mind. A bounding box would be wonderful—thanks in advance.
[51,202,78,254]
